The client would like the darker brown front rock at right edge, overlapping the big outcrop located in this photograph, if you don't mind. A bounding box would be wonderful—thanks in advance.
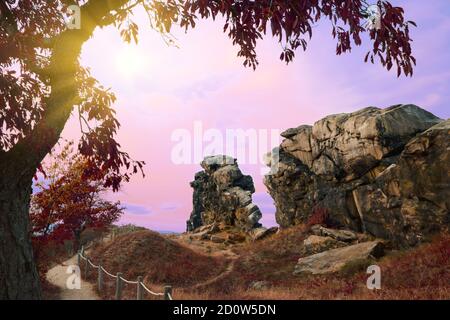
[354,120,450,246]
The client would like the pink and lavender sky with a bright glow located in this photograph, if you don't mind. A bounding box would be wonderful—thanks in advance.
[63,0,450,232]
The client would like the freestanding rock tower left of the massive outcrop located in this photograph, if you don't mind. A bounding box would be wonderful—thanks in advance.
[187,156,262,232]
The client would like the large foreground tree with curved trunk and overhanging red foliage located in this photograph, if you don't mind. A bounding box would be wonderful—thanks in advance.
[0,0,415,299]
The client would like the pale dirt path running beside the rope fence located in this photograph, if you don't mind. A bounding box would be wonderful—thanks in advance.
[47,256,100,300]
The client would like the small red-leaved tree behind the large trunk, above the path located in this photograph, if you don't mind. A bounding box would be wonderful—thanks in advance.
[30,143,123,252]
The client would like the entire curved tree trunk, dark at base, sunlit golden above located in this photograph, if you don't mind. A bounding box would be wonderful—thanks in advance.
[0,0,132,300]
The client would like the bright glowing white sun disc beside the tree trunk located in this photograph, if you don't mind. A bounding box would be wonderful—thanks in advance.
[115,45,147,77]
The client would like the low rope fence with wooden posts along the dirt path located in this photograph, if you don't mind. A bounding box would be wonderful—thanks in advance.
[77,247,173,300]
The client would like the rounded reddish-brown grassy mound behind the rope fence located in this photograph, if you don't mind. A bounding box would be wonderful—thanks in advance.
[85,230,227,299]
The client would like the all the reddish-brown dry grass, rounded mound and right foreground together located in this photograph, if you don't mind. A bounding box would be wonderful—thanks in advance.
[79,226,450,300]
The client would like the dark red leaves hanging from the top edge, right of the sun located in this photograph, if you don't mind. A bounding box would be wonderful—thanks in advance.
[178,0,415,75]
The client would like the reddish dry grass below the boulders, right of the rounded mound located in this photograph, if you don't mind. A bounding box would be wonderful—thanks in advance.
[193,229,450,300]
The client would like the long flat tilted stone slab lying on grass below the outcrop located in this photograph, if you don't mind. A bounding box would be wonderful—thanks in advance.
[294,241,383,274]
